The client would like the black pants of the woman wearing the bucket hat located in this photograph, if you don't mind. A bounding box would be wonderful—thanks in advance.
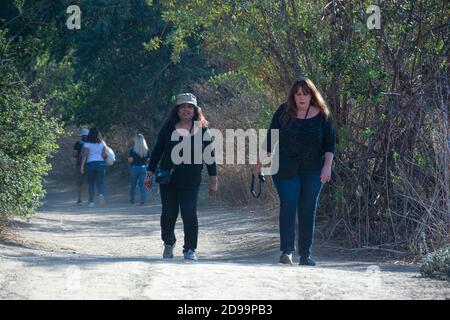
[159,184,198,251]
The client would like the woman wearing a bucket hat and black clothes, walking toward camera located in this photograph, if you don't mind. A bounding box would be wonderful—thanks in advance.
[147,93,218,260]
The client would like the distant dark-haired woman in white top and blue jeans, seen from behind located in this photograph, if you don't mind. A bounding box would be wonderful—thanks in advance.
[80,127,107,208]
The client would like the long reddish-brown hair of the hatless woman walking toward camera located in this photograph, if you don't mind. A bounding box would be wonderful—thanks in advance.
[281,77,331,124]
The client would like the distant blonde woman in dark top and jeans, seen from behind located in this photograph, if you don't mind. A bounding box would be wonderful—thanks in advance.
[128,133,150,205]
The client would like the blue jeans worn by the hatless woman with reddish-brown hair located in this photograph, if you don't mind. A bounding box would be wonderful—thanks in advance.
[272,171,323,257]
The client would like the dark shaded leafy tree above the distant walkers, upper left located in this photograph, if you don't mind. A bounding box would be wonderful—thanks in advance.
[1,0,214,131]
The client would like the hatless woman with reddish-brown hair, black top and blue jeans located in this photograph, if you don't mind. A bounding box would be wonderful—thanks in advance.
[254,78,335,266]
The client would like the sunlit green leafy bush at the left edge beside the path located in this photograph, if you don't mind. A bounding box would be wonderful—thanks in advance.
[0,31,60,217]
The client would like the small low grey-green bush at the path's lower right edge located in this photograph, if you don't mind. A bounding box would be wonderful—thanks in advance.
[420,245,450,281]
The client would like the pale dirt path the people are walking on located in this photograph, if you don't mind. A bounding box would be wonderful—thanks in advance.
[0,175,450,299]
